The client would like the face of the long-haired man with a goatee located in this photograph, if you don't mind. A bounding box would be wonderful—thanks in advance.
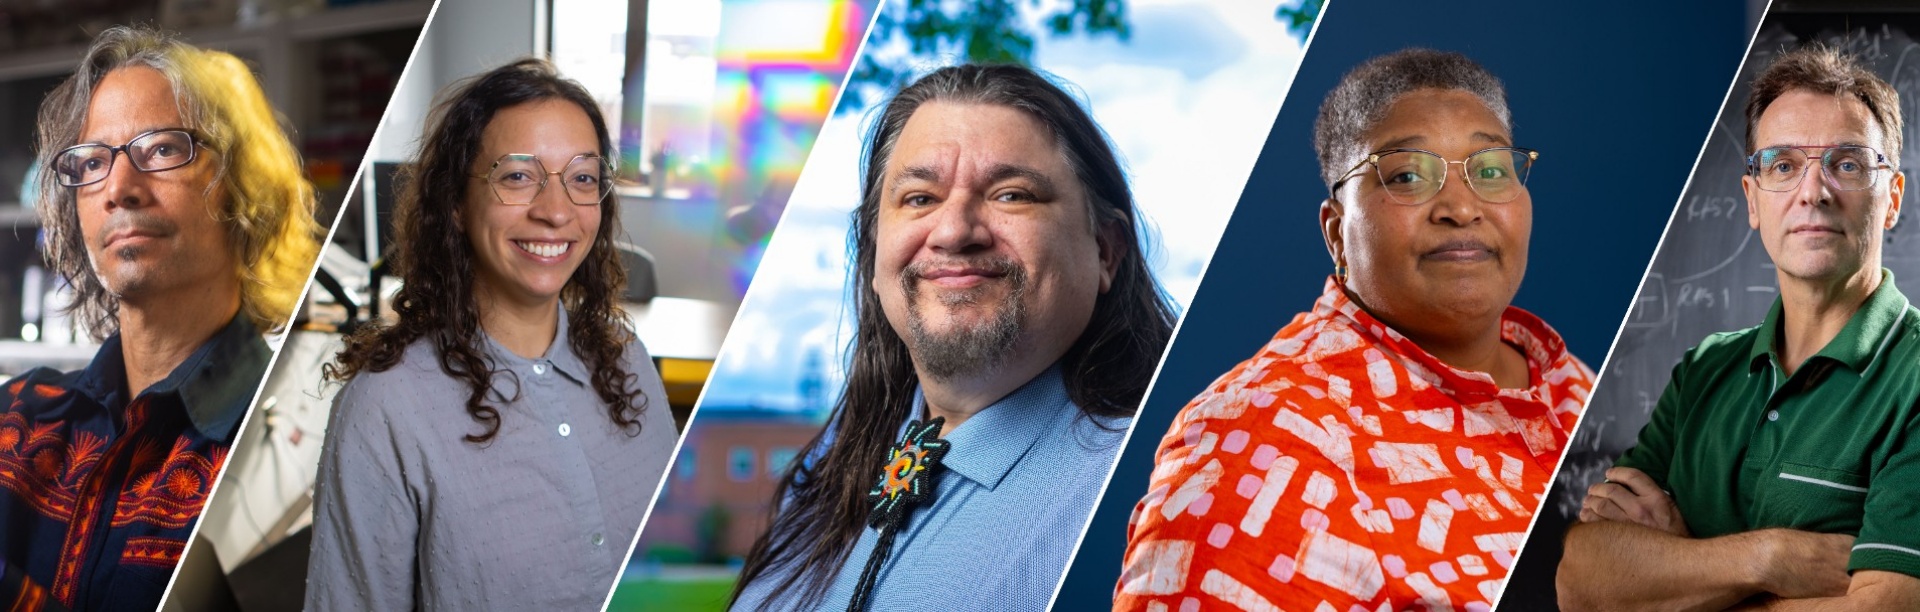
[874,102,1114,378]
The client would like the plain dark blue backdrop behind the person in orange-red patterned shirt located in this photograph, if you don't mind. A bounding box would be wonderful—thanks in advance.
[1056,0,1751,610]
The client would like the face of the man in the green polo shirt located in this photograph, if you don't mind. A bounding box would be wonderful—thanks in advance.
[1740,90,1907,282]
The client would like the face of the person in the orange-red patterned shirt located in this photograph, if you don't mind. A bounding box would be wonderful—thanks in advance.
[1321,88,1534,332]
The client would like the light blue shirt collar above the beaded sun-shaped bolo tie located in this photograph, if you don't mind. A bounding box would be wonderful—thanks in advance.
[912,365,1079,491]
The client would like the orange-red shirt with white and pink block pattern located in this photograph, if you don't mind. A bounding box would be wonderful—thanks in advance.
[1114,278,1594,612]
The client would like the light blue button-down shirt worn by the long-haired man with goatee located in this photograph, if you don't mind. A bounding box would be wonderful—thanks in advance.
[733,368,1131,610]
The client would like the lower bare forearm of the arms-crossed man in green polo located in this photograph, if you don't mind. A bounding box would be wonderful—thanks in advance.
[1555,520,1761,612]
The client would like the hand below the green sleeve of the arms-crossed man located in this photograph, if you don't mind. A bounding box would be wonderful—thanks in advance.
[1747,530,1853,599]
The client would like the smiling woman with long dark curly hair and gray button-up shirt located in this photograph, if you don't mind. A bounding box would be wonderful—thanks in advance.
[307,59,676,610]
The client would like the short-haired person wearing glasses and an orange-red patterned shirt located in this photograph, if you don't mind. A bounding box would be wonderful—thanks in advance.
[1116,50,1594,610]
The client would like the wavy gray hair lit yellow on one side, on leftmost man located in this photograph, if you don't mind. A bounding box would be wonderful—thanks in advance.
[35,27,323,340]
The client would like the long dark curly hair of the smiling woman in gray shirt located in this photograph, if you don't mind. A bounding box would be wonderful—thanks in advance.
[326,59,647,443]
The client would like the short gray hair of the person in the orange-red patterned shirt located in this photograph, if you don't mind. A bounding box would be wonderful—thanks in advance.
[1313,48,1513,190]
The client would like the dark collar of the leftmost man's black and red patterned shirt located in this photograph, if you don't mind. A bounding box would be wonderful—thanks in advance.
[75,311,273,441]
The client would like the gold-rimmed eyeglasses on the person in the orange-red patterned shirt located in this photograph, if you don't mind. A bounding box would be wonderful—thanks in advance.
[1329,146,1540,205]
